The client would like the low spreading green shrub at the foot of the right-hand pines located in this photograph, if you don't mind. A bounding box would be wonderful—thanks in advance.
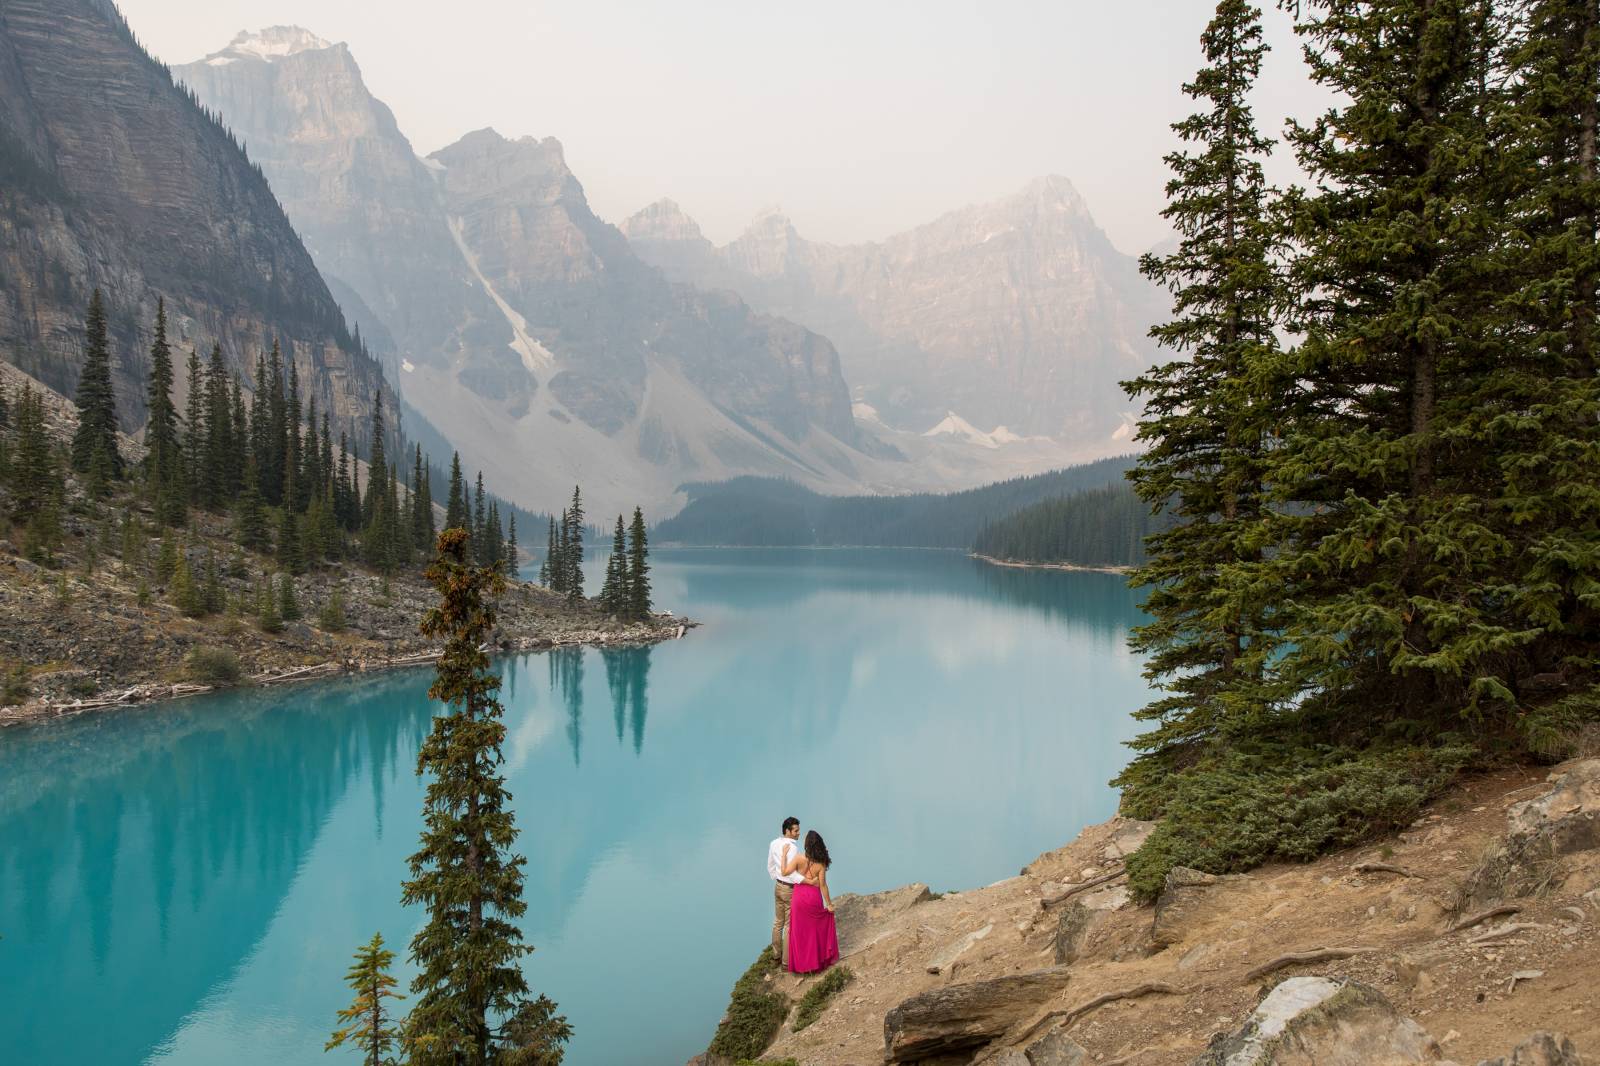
[1128,744,1475,903]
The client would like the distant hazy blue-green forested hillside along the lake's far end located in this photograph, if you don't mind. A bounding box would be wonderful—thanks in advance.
[656,456,1133,551]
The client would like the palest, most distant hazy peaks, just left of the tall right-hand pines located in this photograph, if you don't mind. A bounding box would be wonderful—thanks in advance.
[622,178,1162,450]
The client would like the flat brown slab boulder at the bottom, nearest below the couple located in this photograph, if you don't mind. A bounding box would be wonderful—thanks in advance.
[883,967,1069,1063]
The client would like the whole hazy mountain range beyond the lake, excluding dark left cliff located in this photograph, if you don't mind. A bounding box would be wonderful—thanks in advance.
[174,27,1149,511]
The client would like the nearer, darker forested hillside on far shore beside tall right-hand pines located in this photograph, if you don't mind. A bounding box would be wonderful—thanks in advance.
[973,485,1170,567]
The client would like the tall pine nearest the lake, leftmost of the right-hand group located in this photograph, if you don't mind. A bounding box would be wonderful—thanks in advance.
[1125,0,1286,781]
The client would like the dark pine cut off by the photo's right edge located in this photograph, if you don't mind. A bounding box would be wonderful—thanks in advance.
[1480,0,1600,739]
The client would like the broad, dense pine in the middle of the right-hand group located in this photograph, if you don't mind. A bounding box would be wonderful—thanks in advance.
[1254,0,1525,726]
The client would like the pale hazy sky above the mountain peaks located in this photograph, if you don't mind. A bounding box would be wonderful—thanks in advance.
[120,0,1323,251]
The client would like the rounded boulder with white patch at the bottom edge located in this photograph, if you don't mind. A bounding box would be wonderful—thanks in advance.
[1192,976,1442,1066]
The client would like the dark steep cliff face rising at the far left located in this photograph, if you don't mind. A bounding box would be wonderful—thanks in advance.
[0,0,382,440]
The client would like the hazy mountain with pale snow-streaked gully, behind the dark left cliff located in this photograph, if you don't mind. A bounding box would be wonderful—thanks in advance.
[178,27,883,509]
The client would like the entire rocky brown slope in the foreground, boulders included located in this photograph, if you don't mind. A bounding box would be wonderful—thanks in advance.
[693,759,1600,1066]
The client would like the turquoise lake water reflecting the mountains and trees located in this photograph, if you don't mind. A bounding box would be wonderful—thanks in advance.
[0,549,1146,1066]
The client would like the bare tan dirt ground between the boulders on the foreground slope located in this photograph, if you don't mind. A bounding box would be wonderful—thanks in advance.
[748,758,1600,1066]
